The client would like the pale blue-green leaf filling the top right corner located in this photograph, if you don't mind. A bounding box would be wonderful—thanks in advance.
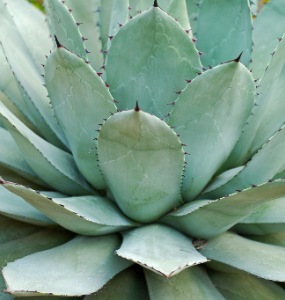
[250,0,285,78]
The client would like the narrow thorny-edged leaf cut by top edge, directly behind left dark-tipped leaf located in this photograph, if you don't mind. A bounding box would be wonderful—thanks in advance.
[48,0,87,61]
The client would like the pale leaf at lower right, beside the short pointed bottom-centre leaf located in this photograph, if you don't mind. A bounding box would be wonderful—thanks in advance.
[199,232,285,281]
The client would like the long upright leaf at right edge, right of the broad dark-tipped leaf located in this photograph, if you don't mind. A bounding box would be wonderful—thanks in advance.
[224,34,285,169]
